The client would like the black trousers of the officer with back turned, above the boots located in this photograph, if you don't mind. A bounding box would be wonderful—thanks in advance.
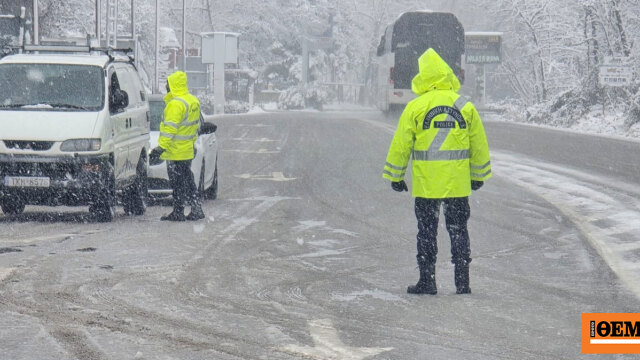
[415,197,471,264]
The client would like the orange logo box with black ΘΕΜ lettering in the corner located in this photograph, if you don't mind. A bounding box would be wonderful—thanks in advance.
[582,313,640,354]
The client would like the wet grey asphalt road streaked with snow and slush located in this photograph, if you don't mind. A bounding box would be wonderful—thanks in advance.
[0,112,640,360]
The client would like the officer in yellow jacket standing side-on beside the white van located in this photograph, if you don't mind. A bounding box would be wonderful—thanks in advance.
[150,71,204,221]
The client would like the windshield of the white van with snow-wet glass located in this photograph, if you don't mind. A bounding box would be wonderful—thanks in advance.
[0,64,104,111]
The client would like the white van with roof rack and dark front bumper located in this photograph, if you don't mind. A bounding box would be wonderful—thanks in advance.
[0,48,150,222]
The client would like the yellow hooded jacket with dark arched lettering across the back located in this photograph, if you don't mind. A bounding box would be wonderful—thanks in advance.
[382,49,491,199]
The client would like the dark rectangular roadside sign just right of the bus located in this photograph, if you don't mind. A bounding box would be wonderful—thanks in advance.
[464,31,502,64]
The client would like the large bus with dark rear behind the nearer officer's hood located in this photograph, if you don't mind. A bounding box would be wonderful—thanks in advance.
[374,11,464,112]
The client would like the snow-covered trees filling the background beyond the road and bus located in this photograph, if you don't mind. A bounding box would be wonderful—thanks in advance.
[13,0,640,124]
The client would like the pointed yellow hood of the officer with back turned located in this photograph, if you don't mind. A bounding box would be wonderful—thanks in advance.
[411,48,460,96]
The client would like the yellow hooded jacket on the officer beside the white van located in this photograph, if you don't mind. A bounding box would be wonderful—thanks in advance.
[158,71,200,161]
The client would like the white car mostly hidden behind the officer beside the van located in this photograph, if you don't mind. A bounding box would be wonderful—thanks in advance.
[148,94,218,199]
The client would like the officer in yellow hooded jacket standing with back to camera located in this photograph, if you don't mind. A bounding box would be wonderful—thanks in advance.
[383,49,491,294]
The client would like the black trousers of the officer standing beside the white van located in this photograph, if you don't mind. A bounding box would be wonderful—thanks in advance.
[167,160,200,209]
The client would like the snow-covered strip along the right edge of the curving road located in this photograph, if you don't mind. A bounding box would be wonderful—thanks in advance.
[492,151,640,299]
